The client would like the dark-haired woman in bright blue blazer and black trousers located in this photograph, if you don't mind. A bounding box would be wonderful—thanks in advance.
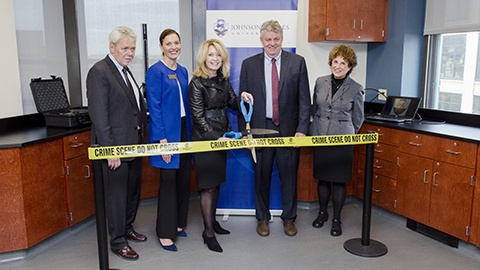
[146,29,191,251]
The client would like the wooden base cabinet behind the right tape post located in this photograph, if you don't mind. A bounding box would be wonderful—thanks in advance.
[354,124,402,212]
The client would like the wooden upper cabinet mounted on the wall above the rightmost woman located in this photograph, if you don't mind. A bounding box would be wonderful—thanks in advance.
[308,0,388,42]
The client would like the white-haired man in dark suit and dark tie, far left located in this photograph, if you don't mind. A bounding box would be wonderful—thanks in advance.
[87,26,147,260]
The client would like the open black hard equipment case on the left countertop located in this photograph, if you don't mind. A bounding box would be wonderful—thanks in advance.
[30,76,91,128]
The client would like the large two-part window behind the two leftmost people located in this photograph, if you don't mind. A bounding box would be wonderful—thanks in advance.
[13,0,192,114]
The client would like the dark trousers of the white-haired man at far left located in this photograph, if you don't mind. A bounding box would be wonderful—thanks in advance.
[102,158,142,249]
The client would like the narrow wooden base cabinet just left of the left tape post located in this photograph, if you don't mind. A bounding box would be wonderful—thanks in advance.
[63,131,95,226]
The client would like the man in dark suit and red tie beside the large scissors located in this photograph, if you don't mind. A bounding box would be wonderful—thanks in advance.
[239,20,311,236]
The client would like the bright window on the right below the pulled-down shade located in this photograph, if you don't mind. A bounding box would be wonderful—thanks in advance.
[425,32,480,114]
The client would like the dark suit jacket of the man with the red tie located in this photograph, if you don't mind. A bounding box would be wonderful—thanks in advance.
[239,51,311,136]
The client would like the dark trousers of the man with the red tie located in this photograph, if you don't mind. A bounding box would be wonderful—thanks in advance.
[255,120,300,221]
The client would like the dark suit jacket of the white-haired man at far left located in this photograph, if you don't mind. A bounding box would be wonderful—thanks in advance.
[87,55,146,154]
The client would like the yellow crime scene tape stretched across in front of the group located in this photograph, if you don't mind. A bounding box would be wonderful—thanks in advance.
[88,133,378,160]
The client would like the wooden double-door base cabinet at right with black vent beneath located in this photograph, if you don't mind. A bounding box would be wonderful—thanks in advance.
[397,132,477,241]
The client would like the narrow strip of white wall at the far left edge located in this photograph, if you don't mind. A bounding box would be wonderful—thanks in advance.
[0,0,23,118]
